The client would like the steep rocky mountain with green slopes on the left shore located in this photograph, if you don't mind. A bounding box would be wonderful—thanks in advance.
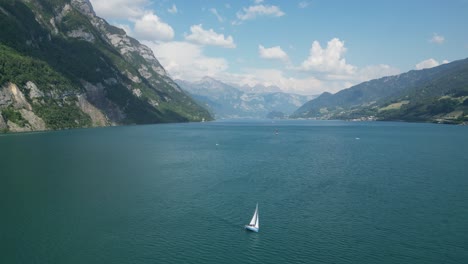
[0,0,211,131]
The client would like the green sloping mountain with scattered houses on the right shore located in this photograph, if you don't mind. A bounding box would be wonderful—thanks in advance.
[292,59,468,123]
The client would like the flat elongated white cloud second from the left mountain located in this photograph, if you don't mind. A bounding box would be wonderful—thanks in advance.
[185,24,236,48]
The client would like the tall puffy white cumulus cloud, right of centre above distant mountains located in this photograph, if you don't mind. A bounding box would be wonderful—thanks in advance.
[300,38,356,75]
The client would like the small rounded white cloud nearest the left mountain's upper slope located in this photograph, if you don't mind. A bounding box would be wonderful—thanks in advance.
[134,12,174,41]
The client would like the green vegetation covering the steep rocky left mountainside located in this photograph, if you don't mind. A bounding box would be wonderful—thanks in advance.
[0,0,211,132]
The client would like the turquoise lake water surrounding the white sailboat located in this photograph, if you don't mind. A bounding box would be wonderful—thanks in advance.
[0,121,468,264]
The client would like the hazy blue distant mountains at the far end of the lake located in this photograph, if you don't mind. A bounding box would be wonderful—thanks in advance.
[176,77,312,119]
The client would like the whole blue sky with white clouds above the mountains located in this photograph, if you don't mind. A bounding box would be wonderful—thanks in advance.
[90,0,468,94]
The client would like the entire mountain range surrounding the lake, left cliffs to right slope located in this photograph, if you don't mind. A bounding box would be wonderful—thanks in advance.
[0,0,468,132]
